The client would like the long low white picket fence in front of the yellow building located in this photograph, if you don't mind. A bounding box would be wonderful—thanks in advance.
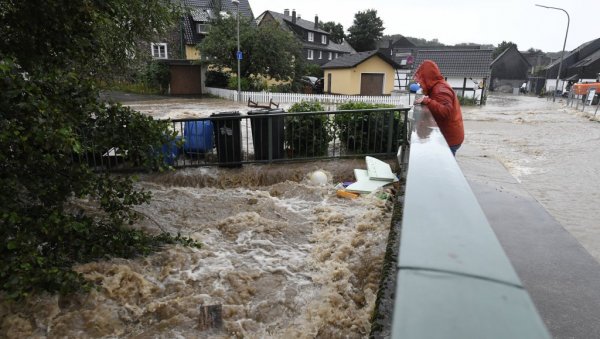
[205,87,414,107]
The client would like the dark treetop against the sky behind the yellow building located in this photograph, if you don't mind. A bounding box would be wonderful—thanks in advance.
[348,9,385,52]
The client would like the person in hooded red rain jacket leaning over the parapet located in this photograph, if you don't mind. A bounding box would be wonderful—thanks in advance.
[414,60,465,155]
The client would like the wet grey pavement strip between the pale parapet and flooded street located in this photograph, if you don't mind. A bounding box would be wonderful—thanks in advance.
[461,145,600,338]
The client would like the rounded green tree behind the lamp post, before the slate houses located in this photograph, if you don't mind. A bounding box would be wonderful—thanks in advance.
[198,16,304,80]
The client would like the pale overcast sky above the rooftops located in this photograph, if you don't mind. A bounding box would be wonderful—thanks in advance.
[249,0,600,52]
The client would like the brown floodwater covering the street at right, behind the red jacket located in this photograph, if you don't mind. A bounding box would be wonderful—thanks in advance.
[457,96,600,261]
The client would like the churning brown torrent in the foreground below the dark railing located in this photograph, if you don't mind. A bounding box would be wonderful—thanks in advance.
[0,161,398,338]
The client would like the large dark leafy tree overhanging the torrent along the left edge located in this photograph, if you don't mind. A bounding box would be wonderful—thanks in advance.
[0,0,197,299]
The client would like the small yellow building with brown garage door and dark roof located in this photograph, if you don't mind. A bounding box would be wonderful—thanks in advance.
[321,51,400,95]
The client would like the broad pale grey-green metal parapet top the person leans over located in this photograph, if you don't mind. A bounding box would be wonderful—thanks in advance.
[392,107,550,339]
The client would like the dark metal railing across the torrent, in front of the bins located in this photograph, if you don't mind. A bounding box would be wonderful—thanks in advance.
[78,108,409,171]
